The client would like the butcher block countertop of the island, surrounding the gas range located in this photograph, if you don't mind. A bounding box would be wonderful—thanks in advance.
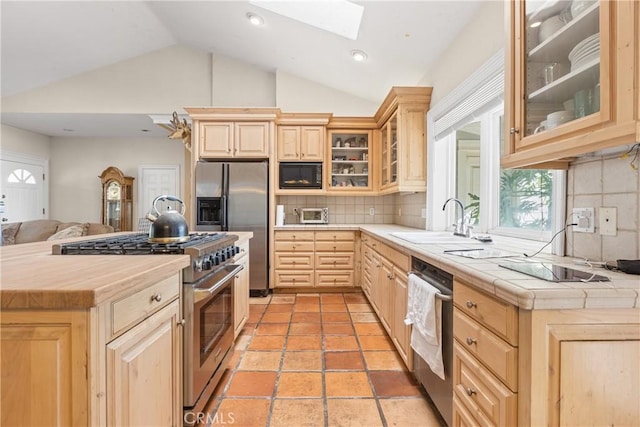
[0,233,252,310]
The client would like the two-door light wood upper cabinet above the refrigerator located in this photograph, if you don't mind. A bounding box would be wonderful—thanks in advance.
[185,108,278,159]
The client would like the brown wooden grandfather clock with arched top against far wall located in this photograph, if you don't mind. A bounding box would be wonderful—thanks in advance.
[99,166,135,231]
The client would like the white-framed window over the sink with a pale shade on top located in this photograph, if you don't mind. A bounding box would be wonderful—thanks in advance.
[427,52,566,253]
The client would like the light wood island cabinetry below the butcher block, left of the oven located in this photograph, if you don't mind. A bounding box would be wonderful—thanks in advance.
[1,273,182,426]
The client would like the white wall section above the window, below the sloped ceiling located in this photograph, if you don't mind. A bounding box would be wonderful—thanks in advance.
[418,1,507,106]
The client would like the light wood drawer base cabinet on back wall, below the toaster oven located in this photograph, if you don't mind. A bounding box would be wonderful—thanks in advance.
[275,231,356,288]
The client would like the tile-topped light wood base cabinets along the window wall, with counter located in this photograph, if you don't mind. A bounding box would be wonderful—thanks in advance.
[276,225,640,426]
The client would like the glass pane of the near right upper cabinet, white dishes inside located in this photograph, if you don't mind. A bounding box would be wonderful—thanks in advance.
[522,0,609,137]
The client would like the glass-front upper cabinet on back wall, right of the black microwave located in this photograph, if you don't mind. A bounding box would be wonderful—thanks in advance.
[325,118,375,195]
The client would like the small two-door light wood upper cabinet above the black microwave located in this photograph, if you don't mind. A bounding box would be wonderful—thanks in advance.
[276,113,331,162]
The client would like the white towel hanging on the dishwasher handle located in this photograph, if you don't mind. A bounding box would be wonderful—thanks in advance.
[404,274,444,380]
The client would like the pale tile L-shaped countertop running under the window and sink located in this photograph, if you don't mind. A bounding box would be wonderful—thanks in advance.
[275,224,640,310]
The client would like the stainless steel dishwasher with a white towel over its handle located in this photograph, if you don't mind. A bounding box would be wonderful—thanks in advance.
[411,257,453,426]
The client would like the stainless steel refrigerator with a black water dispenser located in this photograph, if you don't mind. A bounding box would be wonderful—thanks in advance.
[195,161,269,296]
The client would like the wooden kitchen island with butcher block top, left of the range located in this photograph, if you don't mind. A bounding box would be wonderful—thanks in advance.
[0,233,251,426]
